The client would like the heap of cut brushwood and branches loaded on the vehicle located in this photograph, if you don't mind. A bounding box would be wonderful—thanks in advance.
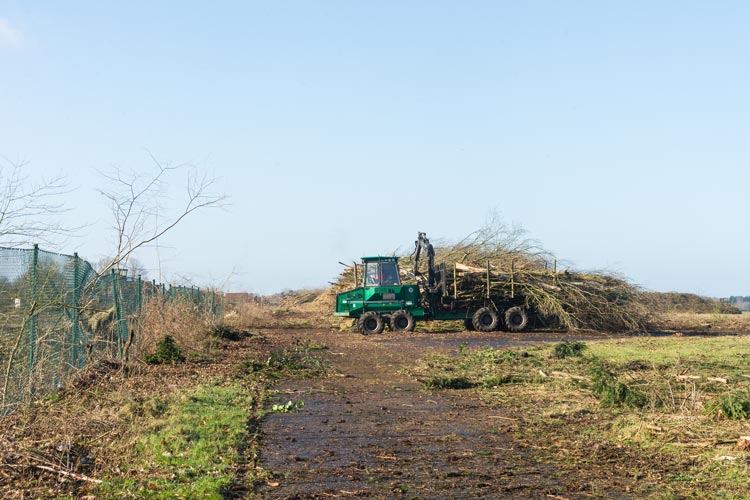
[331,219,648,331]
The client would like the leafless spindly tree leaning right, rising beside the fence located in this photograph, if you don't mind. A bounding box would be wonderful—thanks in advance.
[94,153,226,273]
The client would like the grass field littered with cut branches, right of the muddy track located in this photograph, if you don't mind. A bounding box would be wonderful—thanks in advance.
[413,336,750,498]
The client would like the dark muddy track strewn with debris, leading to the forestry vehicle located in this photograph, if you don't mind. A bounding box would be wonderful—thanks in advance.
[256,331,629,499]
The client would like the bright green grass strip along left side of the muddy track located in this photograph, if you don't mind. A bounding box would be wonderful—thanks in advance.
[100,382,253,499]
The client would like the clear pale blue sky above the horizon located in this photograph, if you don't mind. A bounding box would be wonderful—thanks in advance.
[0,0,750,296]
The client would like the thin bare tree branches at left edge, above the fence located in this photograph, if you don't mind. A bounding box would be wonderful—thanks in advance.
[0,155,75,247]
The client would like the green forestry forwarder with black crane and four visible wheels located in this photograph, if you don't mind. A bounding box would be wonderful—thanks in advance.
[334,233,529,335]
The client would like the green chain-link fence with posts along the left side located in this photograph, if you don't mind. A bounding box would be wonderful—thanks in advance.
[0,246,223,415]
